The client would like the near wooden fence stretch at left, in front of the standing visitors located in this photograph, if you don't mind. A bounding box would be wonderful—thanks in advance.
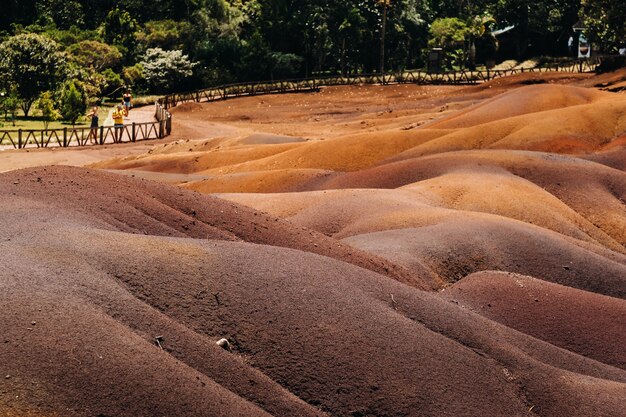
[0,103,172,149]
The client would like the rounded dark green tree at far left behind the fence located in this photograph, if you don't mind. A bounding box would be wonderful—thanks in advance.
[0,33,66,117]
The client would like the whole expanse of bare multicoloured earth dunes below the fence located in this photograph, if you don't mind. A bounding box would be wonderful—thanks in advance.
[0,73,626,416]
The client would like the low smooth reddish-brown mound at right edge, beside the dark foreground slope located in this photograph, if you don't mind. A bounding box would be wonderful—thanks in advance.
[444,272,626,369]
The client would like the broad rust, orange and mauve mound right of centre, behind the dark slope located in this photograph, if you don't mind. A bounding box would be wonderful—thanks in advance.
[222,147,626,297]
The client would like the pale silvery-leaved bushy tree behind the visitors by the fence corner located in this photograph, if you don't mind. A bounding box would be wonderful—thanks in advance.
[141,48,196,93]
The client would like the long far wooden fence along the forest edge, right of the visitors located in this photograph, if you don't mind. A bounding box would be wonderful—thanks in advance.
[159,57,601,109]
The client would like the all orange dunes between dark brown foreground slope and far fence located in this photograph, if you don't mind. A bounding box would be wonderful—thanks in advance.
[94,76,626,297]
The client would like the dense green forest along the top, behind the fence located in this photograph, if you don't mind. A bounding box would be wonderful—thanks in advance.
[0,0,626,122]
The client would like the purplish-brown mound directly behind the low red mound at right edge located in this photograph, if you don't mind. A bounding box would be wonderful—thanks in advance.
[343,215,626,298]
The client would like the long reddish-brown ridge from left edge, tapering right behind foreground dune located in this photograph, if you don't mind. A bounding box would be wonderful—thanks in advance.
[0,167,420,287]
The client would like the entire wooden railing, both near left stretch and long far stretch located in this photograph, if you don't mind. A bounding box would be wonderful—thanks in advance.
[0,57,602,149]
